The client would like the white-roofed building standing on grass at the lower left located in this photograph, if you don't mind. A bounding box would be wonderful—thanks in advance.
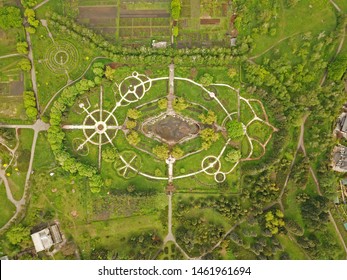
[31,224,63,253]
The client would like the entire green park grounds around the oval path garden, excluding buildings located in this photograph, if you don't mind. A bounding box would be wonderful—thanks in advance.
[0,0,347,260]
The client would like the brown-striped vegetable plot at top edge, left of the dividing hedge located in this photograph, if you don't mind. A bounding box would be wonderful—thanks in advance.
[78,0,171,45]
